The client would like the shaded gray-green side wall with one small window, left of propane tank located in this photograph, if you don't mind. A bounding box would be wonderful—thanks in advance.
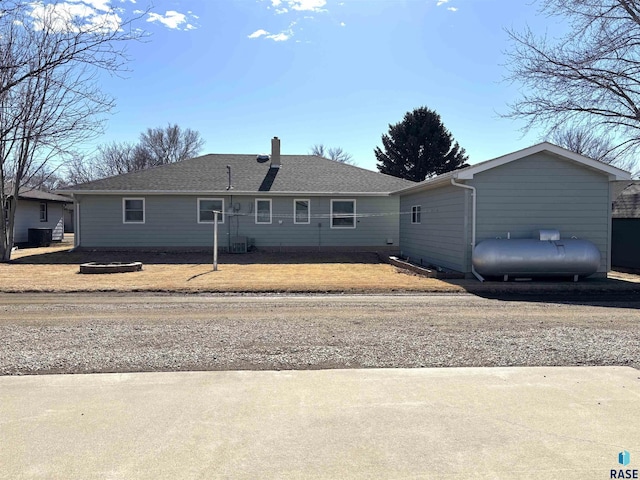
[400,186,469,272]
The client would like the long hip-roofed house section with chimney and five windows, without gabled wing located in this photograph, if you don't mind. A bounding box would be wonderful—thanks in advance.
[63,137,414,252]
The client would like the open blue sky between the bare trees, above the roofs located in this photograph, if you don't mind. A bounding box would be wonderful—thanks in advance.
[47,0,546,170]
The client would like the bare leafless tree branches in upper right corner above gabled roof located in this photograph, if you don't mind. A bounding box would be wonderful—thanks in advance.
[506,0,640,172]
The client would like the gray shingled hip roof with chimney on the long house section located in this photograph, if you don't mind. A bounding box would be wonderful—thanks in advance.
[61,154,414,194]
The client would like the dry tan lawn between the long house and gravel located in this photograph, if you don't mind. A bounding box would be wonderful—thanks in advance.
[0,239,463,293]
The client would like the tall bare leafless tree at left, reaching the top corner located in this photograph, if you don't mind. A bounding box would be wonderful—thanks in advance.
[0,0,141,261]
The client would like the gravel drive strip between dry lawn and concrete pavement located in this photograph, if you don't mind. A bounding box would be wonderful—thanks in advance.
[0,295,640,375]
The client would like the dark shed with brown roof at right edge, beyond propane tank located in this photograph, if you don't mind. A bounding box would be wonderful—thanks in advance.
[611,182,640,269]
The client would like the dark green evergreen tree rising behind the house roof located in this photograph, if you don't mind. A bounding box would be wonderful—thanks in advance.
[374,107,469,182]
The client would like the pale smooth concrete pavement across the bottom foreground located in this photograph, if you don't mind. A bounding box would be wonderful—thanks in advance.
[0,367,640,480]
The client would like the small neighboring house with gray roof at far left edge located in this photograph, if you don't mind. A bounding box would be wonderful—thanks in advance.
[5,187,73,244]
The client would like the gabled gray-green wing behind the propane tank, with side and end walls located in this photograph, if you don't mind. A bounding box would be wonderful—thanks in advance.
[396,143,631,278]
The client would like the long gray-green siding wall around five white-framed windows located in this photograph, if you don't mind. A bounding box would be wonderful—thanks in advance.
[77,194,399,248]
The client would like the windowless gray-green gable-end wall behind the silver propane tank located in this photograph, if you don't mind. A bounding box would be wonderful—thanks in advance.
[467,153,610,272]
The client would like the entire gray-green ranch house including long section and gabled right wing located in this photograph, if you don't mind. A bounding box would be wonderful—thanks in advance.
[65,138,631,280]
